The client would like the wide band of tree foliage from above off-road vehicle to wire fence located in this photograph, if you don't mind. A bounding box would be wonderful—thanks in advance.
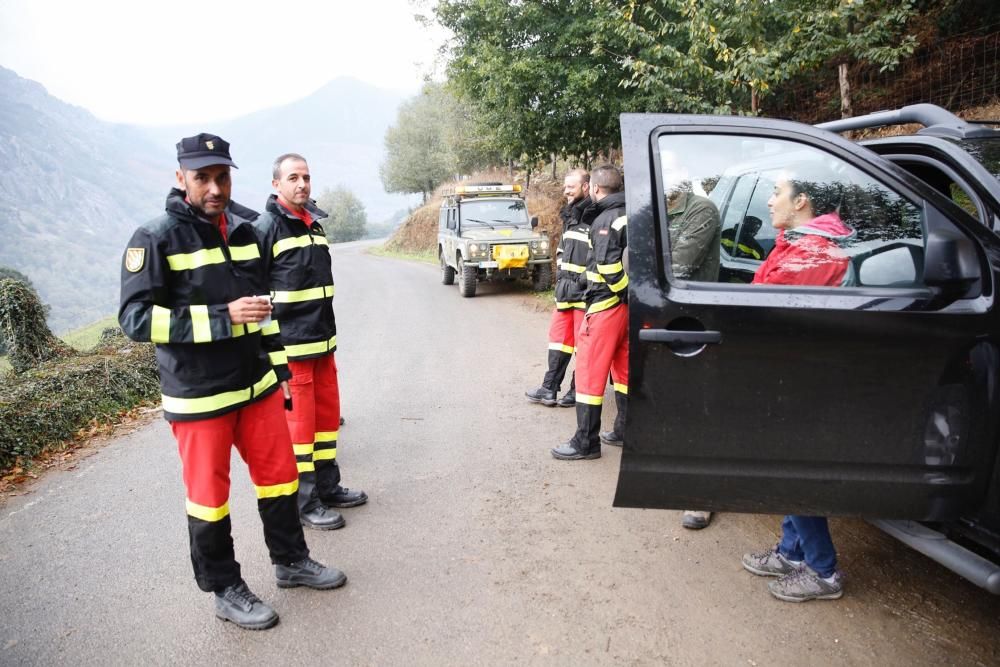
[435,0,916,149]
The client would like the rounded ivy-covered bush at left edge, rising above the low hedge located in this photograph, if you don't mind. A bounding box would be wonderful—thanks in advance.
[0,278,73,373]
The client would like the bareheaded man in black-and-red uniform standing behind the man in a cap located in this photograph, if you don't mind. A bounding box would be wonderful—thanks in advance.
[254,153,368,530]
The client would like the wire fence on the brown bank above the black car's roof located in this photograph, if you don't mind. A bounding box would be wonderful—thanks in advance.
[763,25,1000,123]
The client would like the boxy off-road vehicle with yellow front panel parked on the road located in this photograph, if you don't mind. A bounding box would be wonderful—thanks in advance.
[438,183,552,297]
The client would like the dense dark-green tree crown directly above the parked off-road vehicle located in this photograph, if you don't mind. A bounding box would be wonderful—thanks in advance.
[435,0,629,162]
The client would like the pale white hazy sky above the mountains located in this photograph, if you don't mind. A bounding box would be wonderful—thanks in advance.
[0,0,445,125]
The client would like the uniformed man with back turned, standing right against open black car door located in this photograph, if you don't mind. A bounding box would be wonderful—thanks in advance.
[552,165,628,461]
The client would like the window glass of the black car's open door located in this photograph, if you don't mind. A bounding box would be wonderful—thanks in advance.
[658,134,924,287]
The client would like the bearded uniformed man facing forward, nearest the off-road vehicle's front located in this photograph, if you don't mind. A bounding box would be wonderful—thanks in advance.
[524,169,591,408]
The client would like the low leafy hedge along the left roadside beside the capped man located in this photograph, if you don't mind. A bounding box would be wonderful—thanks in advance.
[0,329,159,470]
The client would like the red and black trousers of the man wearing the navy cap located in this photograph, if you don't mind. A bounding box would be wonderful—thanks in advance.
[170,390,309,591]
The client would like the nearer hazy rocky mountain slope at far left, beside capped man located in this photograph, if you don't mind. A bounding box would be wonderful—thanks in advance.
[0,68,171,331]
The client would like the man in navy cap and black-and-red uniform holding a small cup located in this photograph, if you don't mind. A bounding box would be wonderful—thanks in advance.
[118,134,347,630]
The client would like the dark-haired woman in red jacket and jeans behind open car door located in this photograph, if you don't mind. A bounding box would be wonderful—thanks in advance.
[743,164,855,602]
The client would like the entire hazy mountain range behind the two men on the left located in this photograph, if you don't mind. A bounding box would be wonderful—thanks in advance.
[0,67,412,332]
